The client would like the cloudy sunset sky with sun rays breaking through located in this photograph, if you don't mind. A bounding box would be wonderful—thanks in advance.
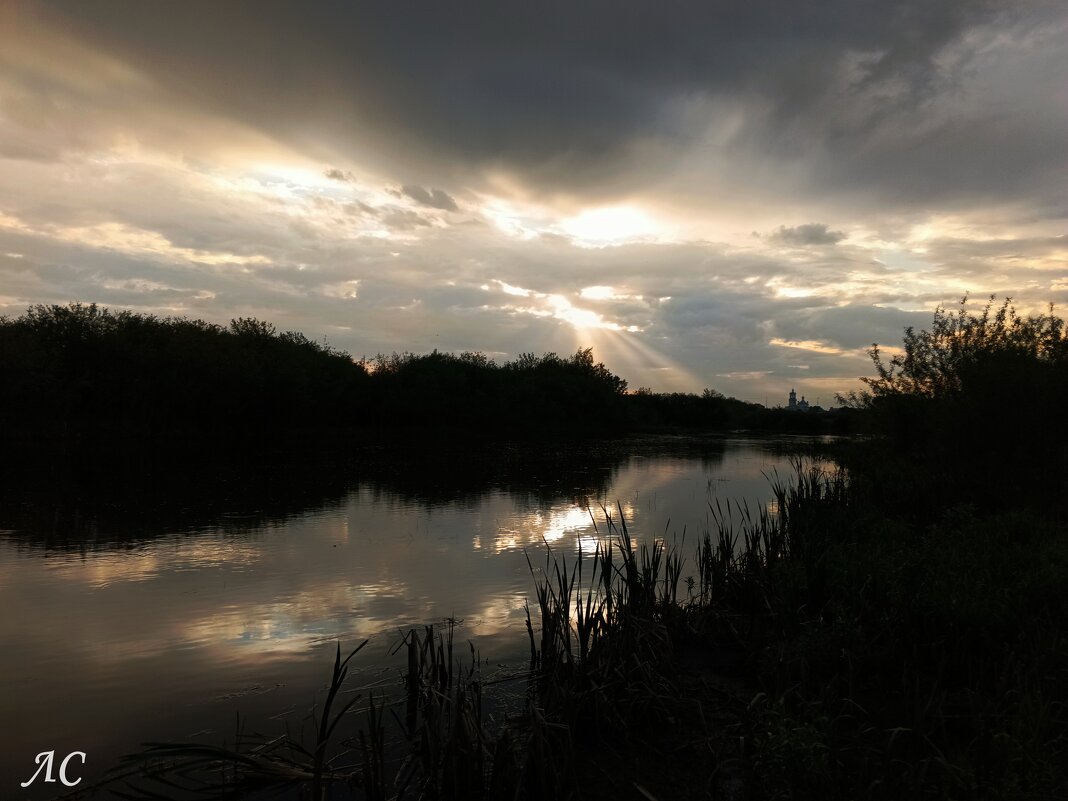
[0,0,1068,406]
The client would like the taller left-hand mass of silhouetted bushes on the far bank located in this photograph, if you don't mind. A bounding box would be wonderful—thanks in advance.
[0,303,370,437]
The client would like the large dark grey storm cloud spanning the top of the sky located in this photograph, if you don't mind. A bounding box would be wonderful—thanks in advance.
[33,0,1064,209]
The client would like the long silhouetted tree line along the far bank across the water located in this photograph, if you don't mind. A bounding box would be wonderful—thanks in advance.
[0,304,850,446]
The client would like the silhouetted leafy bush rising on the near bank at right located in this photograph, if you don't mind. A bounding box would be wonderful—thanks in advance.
[847,298,1068,514]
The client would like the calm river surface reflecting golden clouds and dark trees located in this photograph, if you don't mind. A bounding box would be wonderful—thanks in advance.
[0,439,815,798]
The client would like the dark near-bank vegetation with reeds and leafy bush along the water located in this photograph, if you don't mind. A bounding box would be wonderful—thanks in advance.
[83,305,1068,801]
